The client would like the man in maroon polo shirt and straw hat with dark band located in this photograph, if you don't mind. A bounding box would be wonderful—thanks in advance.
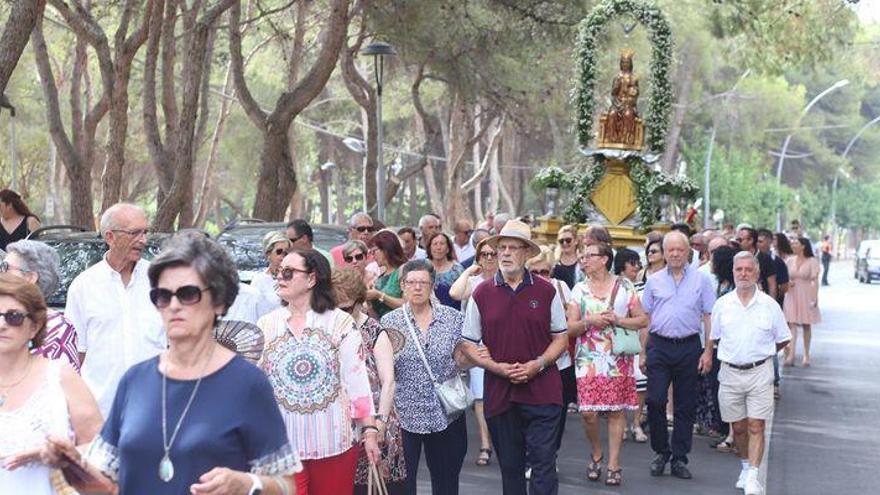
[462,220,568,495]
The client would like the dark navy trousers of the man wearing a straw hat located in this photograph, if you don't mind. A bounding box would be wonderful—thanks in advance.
[486,403,561,495]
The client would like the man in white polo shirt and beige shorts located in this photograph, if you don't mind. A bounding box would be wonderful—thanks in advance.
[711,251,791,495]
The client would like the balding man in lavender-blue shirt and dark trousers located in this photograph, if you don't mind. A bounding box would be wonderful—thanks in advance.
[640,231,715,479]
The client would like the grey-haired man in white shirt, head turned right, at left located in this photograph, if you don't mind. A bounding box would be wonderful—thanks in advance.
[64,203,166,417]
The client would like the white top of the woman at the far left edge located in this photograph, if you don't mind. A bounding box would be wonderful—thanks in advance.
[0,360,73,495]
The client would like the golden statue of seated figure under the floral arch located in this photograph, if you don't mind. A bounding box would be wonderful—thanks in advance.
[598,48,645,150]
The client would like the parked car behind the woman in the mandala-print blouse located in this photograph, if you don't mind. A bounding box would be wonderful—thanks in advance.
[217,218,348,283]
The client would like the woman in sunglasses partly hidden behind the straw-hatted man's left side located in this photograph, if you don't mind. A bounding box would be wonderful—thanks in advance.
[449,239,498,466]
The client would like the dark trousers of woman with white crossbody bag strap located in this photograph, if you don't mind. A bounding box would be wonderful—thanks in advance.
[400,414,467,495]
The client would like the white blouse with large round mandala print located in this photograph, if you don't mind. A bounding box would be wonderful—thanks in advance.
[257,307,375,459]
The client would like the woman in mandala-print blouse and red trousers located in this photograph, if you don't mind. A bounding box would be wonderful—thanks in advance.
[257,249,380,495]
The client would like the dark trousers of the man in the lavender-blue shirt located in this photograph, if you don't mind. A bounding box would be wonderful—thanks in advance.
[645,334,703,463]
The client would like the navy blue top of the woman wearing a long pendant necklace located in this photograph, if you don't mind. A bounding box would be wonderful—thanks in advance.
[89,356,301,495]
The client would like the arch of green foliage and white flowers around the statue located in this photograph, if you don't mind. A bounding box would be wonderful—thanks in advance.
[574,0,673,151]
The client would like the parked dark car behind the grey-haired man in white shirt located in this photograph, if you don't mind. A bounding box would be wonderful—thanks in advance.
[28,225,169,310]
